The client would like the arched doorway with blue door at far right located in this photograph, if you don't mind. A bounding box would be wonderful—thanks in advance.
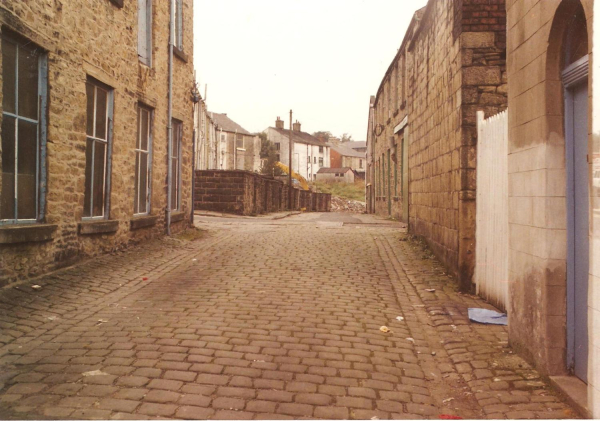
[561,2,590,382]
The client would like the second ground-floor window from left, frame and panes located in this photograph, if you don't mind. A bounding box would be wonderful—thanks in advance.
[83,78,113,218]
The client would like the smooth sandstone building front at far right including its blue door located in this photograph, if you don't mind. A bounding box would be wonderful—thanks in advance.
[507,0,600,418]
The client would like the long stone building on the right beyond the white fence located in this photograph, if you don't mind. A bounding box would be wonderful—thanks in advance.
[367,0,507,289]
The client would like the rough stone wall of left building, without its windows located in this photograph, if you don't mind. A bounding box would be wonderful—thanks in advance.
[0,0,193,285]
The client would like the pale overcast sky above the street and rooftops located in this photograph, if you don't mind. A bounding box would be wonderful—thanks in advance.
[194,0,427,140]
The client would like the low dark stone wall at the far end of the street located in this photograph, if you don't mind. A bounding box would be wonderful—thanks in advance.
[194,170,331,215]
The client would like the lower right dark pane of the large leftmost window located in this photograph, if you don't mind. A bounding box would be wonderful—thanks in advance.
[17,120,38,219]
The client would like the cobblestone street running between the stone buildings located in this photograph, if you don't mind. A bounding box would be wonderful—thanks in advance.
[0,213,577,420]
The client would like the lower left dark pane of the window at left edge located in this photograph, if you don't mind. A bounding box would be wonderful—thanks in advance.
[0,115,15,219]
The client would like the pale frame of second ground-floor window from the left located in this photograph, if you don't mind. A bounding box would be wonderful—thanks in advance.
[81,77,114,221]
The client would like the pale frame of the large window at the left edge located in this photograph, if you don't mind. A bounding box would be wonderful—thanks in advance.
[0,33,48,225]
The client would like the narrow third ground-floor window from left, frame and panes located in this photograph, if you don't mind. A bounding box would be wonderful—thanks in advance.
[133,104,152,215]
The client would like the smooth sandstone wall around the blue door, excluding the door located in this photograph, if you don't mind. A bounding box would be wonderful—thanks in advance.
[507,0,600,378]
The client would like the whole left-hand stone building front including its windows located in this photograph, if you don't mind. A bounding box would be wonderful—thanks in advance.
[0,0,194,285]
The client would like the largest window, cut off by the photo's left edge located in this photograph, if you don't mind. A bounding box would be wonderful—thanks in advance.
[0,33,48,224]
